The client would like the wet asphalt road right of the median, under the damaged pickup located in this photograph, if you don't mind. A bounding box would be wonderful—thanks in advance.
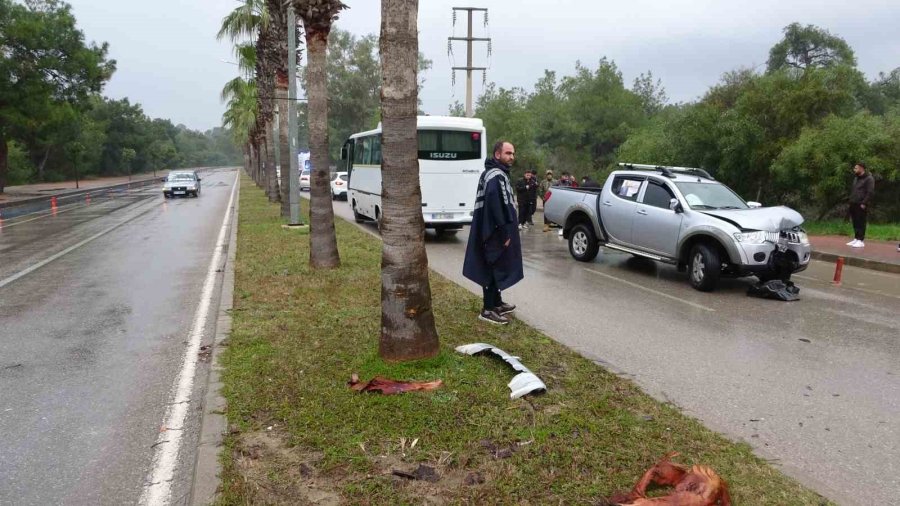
[324,197,900,505]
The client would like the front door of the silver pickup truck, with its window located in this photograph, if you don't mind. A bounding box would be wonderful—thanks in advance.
[632,178,684,258]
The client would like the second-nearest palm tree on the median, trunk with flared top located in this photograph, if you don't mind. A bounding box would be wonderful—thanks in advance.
[293,0,347,269]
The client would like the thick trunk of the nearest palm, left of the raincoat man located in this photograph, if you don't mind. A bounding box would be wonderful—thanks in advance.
[378,0,440,361]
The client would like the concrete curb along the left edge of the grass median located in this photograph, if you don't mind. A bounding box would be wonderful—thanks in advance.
[190,173,241,506]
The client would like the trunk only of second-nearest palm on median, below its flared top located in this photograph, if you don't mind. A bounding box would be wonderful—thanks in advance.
[306,26,341,269]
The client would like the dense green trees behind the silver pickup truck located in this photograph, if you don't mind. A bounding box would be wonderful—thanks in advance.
[474,23,900,223]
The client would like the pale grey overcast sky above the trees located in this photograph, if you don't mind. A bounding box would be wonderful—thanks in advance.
[70,0,900,130]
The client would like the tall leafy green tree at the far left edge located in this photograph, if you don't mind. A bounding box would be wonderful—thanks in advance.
[0,0,115,193]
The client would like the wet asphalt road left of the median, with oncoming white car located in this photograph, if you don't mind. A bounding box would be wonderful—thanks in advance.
[0,170,236,505]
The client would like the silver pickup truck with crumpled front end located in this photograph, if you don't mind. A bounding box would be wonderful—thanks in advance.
[544,164,810,291]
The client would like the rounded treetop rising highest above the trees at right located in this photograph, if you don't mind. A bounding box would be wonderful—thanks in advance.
[768,23,856,72]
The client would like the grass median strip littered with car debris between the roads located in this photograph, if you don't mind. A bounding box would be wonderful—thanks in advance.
[219,173,823,505]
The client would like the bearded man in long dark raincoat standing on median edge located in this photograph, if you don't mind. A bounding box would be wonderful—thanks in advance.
[463,141,525,325]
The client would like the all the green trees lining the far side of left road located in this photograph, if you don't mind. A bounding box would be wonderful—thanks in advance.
[0,0,241,193]
